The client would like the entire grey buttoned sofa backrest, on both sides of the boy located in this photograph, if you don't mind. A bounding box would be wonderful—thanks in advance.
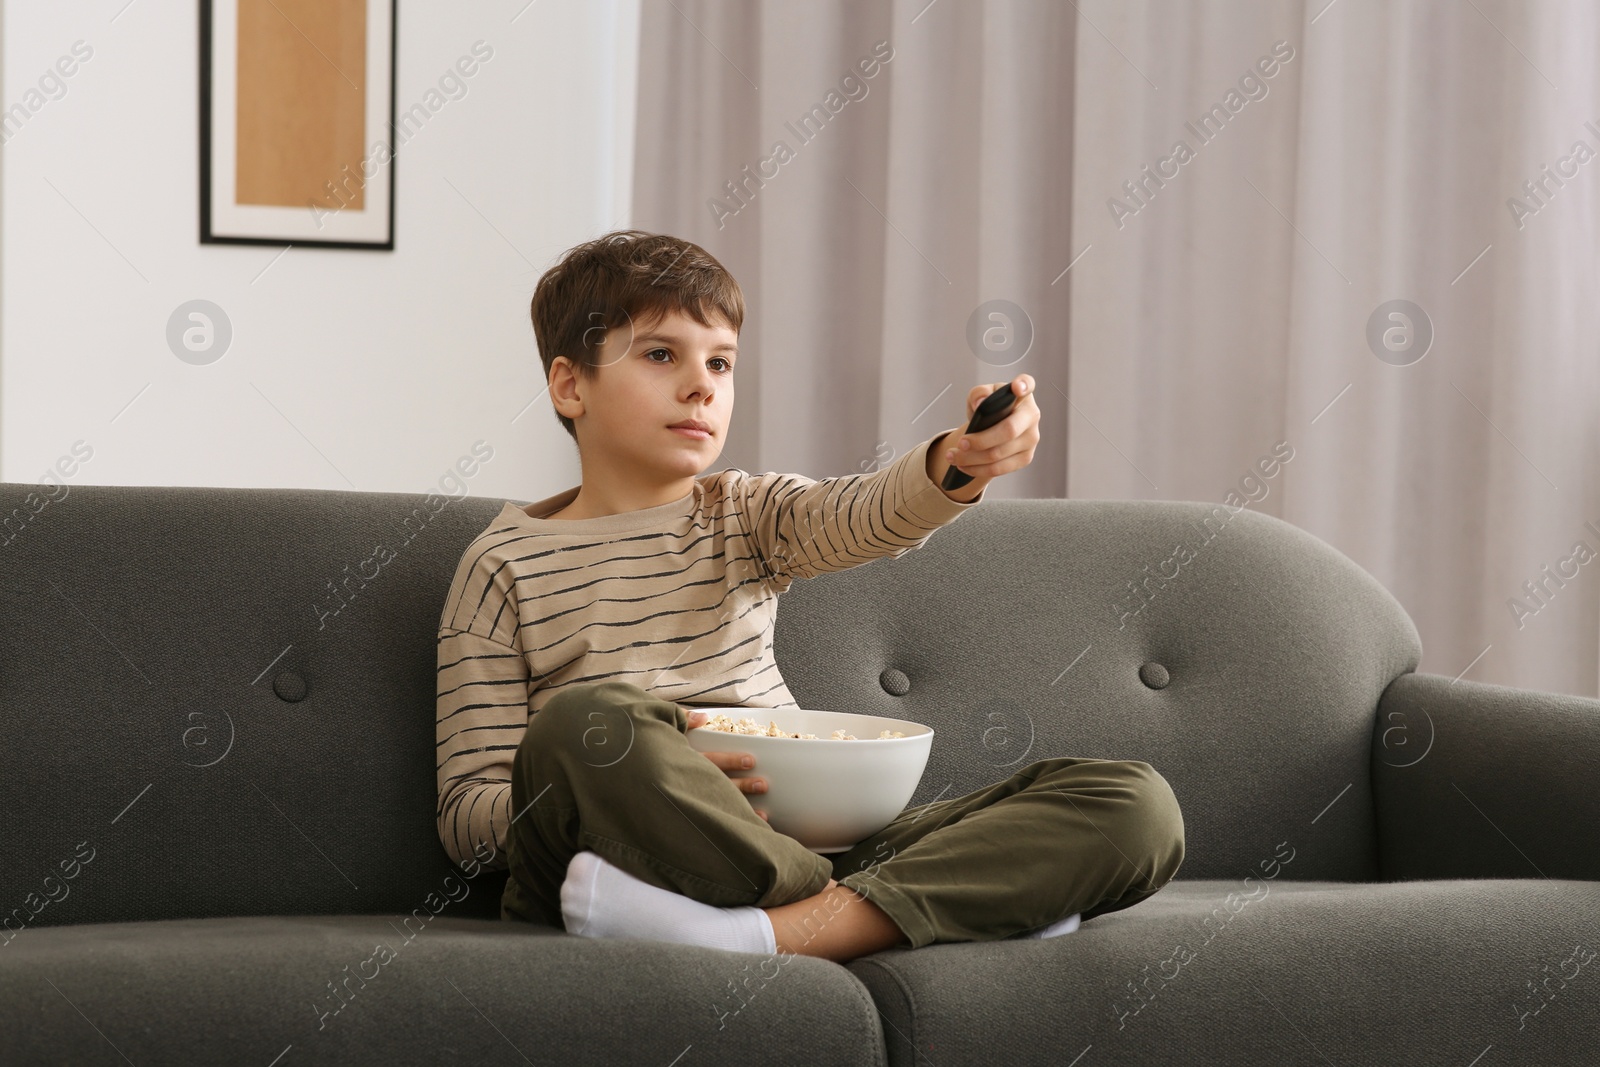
[0,483,1419,931]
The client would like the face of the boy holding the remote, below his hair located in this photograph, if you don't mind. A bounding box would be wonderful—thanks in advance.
[573,309,739,482]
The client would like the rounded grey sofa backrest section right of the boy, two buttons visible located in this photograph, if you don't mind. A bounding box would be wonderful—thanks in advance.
[773,499,1421,881]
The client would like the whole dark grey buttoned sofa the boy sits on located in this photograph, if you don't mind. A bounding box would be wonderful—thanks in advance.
[0,483,1600,1067]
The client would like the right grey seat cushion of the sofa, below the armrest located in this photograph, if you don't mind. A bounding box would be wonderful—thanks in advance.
[848,878,1600,1067]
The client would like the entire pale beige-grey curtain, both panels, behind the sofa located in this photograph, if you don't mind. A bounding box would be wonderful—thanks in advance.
[635,0,1600,696]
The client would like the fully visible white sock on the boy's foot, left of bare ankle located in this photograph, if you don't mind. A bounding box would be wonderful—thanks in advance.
[562,849,778,953]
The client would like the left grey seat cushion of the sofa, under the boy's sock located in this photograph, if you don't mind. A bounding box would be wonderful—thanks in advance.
[0,915,885,1067]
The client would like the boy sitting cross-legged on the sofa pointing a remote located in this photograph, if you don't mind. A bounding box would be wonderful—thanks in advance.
[438,230,1182,961]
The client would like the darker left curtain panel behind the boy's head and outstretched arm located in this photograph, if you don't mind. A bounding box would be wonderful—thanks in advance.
[634,0,1074,496]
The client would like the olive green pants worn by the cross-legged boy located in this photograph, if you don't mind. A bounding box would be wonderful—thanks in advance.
[501,681,1184,949]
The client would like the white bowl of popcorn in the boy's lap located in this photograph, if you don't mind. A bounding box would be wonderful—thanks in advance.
[688,707,933,853]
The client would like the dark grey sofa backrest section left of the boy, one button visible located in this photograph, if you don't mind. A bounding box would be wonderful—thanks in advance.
[0,483,504,939]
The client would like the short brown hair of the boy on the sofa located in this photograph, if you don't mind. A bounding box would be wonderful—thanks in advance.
[530,230,744,442]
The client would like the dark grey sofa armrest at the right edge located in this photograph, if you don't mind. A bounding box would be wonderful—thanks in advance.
[1373,673,1600,881]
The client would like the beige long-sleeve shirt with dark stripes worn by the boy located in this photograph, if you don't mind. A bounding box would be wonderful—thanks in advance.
[437,438,982,870]
